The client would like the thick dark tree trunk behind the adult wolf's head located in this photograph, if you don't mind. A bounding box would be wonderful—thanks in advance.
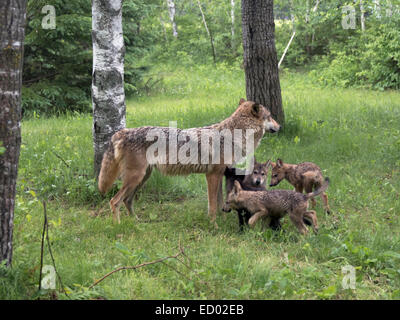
[242,0,285,125]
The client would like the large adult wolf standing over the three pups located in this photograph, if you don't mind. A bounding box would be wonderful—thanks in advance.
[98,99,280,227]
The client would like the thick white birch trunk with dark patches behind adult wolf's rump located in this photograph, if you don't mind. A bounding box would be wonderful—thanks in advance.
[92,0,126,178]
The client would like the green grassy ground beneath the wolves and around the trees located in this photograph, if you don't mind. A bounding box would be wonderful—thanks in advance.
[0,66,400,299]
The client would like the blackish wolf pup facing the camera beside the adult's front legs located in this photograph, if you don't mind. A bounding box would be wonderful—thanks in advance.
[224,157,281,231]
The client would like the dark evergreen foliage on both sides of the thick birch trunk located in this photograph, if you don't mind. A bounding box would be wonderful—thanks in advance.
[22,0,158,115]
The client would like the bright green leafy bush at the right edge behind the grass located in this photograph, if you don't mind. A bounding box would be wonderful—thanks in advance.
[311,17,400,90]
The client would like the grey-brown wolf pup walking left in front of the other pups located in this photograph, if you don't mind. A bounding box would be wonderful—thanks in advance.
[224,178,329,235]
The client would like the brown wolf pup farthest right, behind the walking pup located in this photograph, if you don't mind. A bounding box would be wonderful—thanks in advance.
[270,159,331,214]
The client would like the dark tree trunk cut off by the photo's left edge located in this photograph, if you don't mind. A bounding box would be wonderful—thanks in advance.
[0,0,26,265]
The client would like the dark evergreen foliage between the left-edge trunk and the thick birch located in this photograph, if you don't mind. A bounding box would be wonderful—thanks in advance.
[22,0,92,114]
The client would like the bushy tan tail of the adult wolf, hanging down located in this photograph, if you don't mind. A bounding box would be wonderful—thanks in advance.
[98,139,119,194]
